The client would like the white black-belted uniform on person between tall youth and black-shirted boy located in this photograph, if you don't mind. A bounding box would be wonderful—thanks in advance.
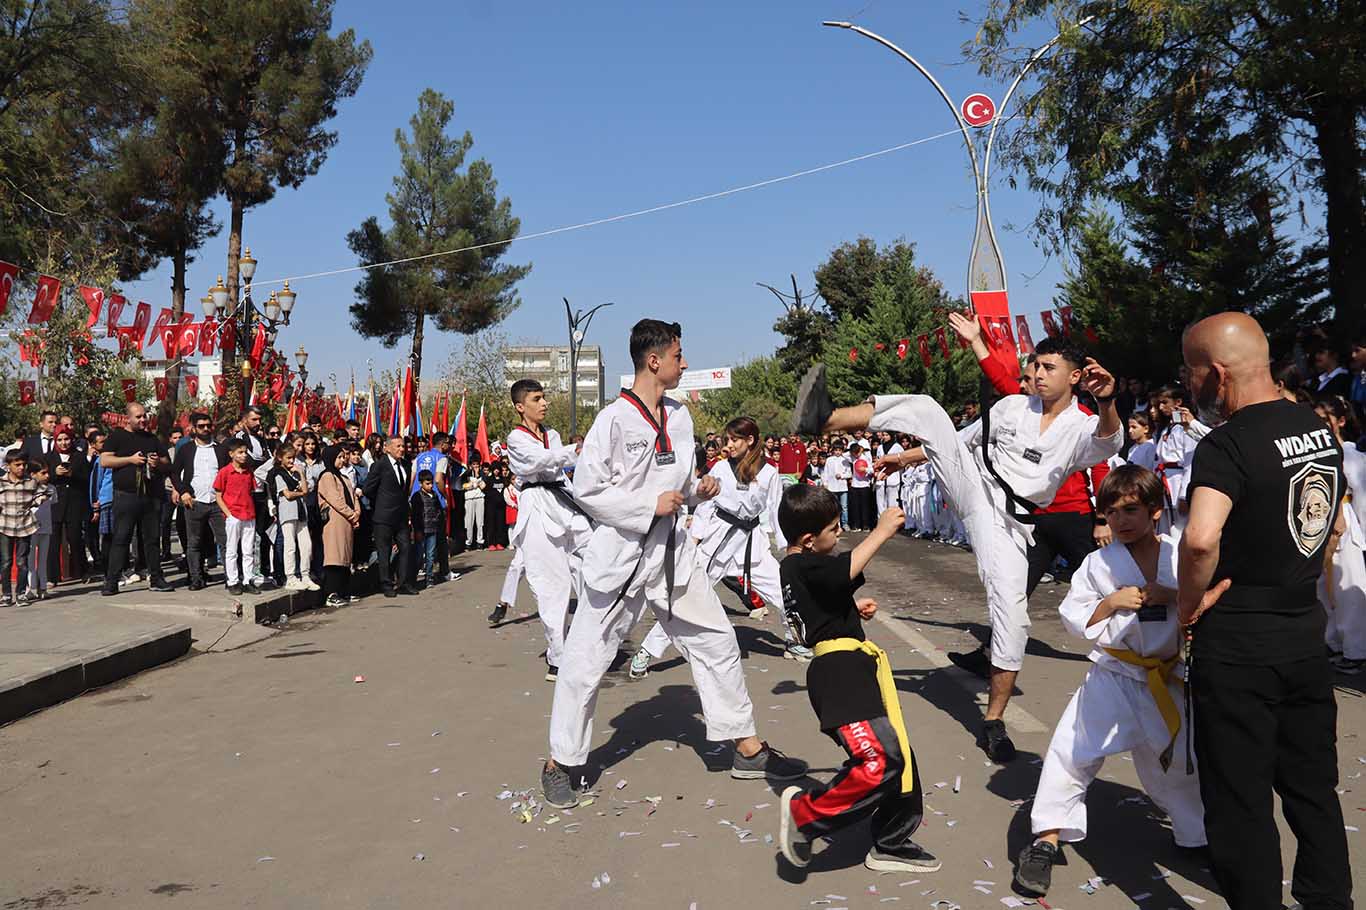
[641,459,800,659]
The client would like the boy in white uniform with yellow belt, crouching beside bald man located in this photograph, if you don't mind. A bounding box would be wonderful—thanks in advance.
[1015,465,1208,895]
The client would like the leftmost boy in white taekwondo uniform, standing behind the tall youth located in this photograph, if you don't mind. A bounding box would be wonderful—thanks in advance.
[489,380,590,682]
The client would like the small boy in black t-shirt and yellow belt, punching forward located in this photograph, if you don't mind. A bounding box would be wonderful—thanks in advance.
[777,484,940,872]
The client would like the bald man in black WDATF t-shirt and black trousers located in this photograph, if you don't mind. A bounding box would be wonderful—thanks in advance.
[1177,313,1352,910]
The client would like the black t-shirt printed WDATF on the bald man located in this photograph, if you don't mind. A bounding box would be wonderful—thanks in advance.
[1190,400,1346,664]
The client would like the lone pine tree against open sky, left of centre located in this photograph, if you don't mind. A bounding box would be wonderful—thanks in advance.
[347,89,531,390]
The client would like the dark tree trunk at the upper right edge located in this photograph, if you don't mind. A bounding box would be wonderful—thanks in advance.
[1311,97,1366,343]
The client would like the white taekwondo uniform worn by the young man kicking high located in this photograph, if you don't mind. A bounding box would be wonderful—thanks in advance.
[869,395,1124,670]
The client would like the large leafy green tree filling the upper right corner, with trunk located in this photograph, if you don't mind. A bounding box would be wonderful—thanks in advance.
[967,0,1366,333]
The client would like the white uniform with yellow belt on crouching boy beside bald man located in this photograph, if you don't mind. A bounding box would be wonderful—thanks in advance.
[1030,537,1208,847]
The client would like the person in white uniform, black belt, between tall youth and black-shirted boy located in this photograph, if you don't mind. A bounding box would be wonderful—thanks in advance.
[628,417,811,666]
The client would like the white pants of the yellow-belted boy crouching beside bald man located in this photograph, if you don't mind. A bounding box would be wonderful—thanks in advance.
[1030,667,1208,847]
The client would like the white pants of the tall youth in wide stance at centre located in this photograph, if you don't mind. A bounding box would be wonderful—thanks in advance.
[546,571,754,767]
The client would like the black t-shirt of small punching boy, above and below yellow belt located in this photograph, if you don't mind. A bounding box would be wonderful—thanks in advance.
[779,553,887,741]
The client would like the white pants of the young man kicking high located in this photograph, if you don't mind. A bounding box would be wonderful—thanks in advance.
[867,395,1030,670]
